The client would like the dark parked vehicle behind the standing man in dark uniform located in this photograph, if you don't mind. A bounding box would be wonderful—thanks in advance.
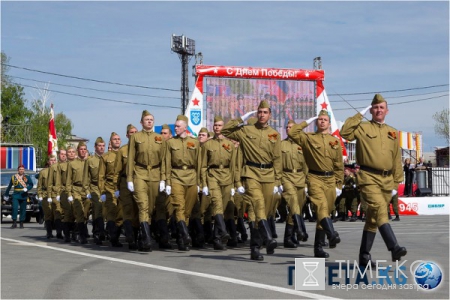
[0,169,42,223]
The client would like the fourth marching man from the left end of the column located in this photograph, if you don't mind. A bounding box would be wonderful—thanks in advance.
[66,142,88,244]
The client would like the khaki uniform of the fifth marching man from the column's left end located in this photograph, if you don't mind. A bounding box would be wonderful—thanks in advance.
[83,153,103,220]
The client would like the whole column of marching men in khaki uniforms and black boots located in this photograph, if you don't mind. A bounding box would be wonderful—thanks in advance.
[38,94,406,265]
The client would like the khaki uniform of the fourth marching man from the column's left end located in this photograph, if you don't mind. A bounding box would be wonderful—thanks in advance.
[66,158,87,223]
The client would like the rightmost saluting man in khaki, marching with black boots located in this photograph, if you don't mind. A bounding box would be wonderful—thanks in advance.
[341,94,407,267]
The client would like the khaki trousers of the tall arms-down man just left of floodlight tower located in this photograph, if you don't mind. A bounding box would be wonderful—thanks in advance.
[133,178,159,223]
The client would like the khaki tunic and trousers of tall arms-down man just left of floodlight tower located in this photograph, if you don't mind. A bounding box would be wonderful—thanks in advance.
[127,130,165,223]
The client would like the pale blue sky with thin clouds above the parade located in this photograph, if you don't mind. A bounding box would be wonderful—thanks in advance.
[1,1,449,152]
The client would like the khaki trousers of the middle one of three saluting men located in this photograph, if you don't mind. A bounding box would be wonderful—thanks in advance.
[308,173,336,230]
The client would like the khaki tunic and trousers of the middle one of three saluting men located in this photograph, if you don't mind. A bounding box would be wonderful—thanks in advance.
[288,121,344,229]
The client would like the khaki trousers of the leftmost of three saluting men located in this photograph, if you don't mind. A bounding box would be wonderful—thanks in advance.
[244,178,275,224]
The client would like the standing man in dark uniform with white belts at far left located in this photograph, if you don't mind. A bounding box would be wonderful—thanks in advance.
[3,165,33,228]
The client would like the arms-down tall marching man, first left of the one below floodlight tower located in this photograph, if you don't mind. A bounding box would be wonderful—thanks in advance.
[127,110,165,251]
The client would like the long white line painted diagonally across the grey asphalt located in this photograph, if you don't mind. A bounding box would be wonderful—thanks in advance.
[0,237,339,299]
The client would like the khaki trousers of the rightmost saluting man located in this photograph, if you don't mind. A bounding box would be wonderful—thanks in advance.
[361,184,392,232]
